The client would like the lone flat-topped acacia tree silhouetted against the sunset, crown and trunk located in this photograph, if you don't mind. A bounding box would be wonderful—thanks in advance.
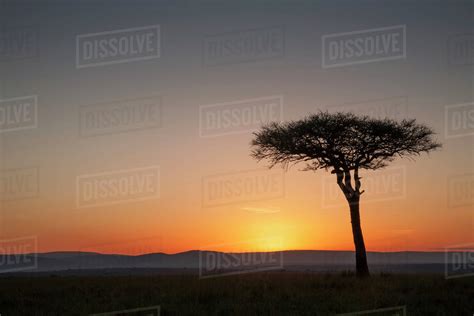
[251,112,441,276]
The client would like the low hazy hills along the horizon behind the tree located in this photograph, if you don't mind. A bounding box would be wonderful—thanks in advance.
[0,250,452,272]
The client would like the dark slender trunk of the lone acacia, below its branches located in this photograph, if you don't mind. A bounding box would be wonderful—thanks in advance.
[348,196,369,277]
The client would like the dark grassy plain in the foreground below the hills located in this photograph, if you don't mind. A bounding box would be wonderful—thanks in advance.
[0,272,474,316]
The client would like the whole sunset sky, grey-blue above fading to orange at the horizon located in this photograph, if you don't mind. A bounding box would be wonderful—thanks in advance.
[0,0,474,254]
